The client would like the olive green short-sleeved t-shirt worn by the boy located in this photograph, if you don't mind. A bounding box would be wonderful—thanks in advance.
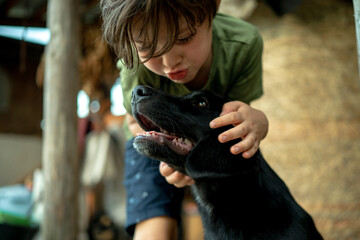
[117,14,263,139]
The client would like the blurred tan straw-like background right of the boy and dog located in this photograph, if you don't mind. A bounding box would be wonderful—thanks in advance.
[214,0,360,240]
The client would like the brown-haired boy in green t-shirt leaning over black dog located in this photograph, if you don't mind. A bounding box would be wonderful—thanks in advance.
[100,0,268,240]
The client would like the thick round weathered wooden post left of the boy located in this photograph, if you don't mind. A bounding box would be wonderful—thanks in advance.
[41,0,80,240]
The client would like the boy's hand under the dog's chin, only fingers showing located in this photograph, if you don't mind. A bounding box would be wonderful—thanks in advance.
[160,162,195,188]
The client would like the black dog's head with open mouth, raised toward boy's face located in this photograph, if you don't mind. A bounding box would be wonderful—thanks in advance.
[132,86,254,179]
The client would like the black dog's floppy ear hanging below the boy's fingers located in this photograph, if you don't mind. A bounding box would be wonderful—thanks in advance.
[185,128,259,180]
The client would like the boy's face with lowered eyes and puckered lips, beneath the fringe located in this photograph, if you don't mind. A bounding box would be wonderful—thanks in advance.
[134,16,212,88]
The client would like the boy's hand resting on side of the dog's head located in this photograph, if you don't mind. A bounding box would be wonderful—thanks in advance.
[210,101,269,158]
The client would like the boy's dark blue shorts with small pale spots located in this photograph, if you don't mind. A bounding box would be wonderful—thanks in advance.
[124,139,184,235]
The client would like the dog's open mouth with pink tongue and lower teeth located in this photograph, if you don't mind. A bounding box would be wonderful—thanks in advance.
[137,114,194,155]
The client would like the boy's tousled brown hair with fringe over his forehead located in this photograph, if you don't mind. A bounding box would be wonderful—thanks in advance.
[100,0,217,69]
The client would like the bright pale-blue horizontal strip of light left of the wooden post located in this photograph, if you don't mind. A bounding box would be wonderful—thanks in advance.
[0,26,50,45]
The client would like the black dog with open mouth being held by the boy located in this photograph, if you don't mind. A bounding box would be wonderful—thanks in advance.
[132,86,322,240]
